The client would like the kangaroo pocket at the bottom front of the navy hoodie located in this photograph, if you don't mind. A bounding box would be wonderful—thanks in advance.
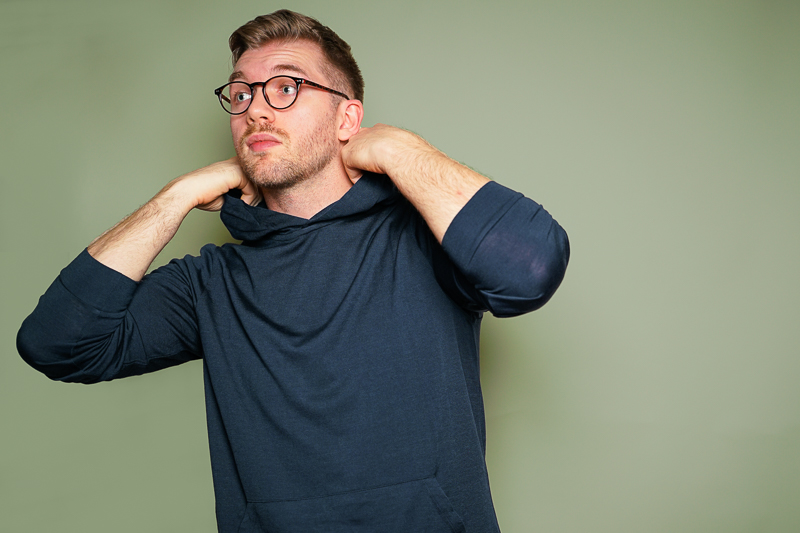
[239,477,465,533]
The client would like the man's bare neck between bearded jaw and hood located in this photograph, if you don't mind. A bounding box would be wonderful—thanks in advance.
[260,164,353,219]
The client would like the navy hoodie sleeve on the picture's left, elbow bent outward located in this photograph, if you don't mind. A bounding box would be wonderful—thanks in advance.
[17,250,199,383]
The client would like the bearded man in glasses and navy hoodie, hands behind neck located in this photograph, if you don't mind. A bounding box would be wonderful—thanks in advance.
[18,10,569,533]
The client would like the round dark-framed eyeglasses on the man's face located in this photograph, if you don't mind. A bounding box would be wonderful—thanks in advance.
[214,76,350,115]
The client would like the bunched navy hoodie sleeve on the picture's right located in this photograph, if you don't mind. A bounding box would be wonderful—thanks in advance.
[436,182,569,317]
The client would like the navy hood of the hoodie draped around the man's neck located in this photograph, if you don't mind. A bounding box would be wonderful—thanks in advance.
[220,172,400,241]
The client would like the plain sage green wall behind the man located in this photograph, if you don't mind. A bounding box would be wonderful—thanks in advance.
[0,0,800,533]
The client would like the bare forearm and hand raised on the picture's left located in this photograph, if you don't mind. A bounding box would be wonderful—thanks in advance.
[88,157,261,281]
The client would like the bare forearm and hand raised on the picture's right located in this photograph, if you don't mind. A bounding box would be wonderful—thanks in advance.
[342,124,489,243]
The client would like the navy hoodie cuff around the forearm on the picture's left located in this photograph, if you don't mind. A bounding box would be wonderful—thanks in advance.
[58,249,138,313]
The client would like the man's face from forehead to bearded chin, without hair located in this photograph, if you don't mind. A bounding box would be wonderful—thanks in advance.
[231,41,340,189]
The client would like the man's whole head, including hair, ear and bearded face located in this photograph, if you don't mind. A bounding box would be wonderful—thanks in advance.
[220,10,364,189]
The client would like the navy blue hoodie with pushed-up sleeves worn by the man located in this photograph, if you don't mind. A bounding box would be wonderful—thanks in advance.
[17,174,569,533]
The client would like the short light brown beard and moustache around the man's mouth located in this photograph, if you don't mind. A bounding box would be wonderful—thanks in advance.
[236,110,339,189]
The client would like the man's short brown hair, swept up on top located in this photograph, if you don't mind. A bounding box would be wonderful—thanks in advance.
[228,9,364,102]
